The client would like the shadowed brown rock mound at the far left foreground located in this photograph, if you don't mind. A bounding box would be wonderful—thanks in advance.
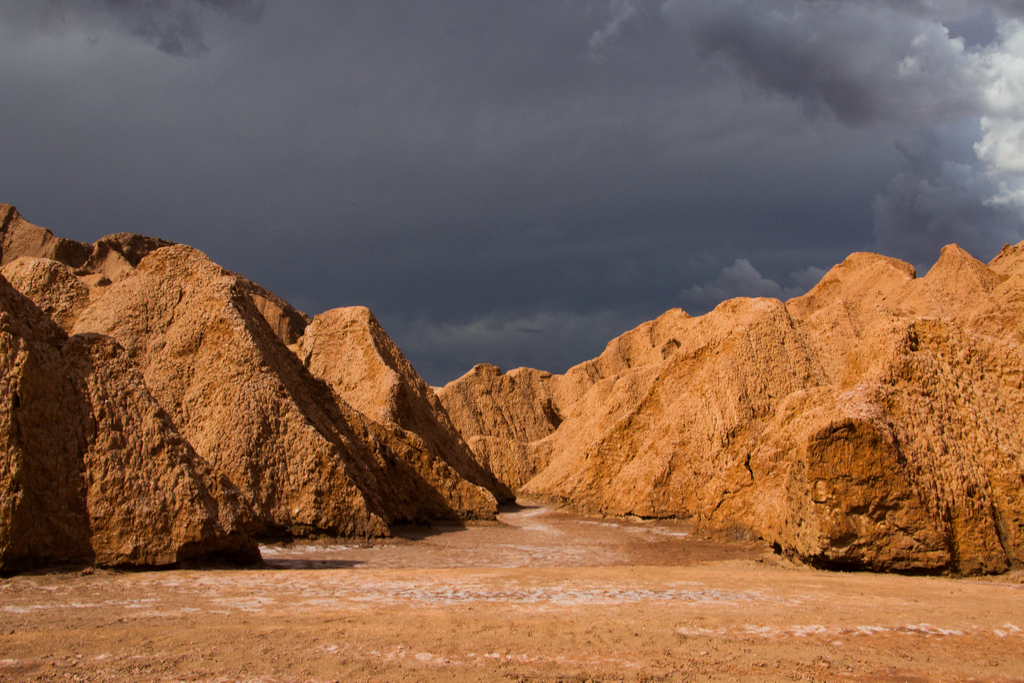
[0,278,259,571]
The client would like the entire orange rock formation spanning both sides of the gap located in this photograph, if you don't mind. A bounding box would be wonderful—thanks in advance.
[8,198,1024,573]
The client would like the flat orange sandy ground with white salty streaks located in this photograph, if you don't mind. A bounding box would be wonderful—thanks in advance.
[0,499,1024,682]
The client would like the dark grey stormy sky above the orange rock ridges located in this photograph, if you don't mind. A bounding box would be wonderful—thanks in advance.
[0,0,1024,384]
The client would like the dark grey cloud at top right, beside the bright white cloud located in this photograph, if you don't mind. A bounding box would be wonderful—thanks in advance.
[666,0,980,126]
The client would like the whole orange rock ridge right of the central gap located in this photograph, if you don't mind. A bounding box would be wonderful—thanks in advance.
[440,246,1024,573]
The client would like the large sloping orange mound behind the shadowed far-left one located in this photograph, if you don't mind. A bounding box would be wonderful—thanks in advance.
[69,246,495,536]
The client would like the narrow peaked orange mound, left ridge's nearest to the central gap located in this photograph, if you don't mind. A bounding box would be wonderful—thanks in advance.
[296,306,514,503]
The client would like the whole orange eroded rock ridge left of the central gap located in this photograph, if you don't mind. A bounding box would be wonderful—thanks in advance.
[0,205,495,570]
